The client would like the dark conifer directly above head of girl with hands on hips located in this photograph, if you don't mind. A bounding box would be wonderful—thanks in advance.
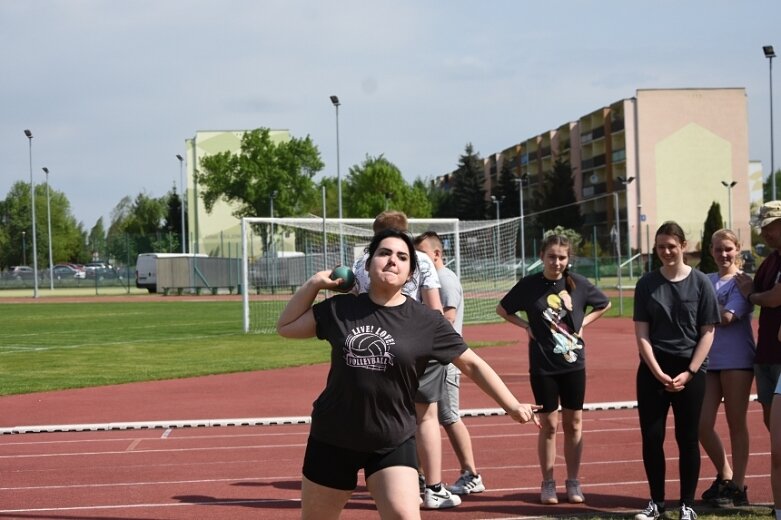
[536,158,582,229]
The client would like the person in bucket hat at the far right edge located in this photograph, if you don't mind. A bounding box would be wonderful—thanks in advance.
[735,200,781,429]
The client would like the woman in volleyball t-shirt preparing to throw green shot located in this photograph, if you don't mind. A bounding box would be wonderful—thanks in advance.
[277,229,539,520]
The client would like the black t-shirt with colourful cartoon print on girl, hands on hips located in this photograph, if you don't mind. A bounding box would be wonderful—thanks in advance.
[499,273,610,375]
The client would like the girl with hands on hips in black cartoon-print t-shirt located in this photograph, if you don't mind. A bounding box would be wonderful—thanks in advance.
[496,234,610,504]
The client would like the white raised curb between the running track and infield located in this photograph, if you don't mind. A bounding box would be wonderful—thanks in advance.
[0,394,757,436]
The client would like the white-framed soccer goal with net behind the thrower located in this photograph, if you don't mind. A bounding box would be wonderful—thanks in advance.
[241,217,520,333]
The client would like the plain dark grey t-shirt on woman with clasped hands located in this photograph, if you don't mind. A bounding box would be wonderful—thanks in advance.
[633,269,721,358]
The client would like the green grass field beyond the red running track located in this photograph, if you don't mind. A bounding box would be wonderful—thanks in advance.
[0,296,631,395]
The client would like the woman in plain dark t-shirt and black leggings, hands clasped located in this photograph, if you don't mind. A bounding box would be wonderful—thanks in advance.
[634,221,721,520]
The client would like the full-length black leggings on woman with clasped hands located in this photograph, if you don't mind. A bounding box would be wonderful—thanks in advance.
[637,350,705,506]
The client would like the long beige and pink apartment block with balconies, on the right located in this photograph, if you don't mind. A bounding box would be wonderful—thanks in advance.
[478,88,762,253]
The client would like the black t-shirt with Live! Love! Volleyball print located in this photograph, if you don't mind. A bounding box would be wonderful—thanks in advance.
[311,293,468,452]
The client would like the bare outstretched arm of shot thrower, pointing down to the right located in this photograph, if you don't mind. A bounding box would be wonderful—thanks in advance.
[453,349,541,427]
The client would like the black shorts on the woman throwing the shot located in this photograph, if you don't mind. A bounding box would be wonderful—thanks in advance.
[303,436,418,491]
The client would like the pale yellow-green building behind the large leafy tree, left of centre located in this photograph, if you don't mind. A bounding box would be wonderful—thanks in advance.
[185,130,290,257]
